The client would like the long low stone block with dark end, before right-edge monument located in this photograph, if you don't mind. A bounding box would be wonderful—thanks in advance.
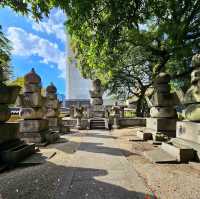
[161,142,195,162]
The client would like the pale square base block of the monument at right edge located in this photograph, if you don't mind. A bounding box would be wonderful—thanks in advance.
[176,121,200,144]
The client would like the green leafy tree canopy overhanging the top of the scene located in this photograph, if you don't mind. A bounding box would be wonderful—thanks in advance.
[3,0,200,110]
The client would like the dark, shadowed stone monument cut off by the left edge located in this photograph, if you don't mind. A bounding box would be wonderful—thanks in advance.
[0,68,35,164]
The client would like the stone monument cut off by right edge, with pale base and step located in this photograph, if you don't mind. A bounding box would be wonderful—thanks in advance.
[145,54,200,162]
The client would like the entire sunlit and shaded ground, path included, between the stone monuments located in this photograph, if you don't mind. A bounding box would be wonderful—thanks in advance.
[0,127,200,199]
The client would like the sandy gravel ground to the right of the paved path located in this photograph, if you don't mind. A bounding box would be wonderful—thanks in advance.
[112,128,200,199]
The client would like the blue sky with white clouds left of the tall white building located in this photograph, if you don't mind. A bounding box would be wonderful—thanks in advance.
[0,8,68,94]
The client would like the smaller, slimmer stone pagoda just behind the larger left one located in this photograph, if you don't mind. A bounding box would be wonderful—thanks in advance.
[45,83,61,132]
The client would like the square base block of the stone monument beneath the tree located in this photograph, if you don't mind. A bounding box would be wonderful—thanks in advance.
[146,118,177,131]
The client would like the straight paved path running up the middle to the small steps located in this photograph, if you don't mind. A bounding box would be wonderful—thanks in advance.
[60,131,150,199]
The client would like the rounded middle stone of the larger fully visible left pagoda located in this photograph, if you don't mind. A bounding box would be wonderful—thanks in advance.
[20,108,44,119]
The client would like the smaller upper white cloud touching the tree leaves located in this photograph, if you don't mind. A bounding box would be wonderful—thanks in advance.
[32,10,66,43]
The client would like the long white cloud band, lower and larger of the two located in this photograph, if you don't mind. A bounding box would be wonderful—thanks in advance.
[7,27,66,78]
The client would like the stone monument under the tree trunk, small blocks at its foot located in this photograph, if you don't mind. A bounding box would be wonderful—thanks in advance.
[137,73,179,141]
